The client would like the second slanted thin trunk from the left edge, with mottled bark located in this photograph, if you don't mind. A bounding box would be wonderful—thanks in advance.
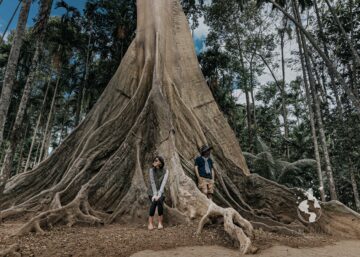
[1,0,53,182]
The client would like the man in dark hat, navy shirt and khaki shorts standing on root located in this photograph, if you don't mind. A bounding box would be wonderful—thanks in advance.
[195,145,215,200]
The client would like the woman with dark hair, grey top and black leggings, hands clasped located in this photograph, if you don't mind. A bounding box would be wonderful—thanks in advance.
[148,156,169,230]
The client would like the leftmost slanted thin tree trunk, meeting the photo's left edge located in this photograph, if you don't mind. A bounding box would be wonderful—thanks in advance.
[0,0,32,146]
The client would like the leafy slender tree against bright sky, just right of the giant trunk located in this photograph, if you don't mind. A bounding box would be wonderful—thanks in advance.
[205,0,274,151]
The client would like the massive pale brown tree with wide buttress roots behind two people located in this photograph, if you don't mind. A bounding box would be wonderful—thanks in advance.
[0,0,360,253]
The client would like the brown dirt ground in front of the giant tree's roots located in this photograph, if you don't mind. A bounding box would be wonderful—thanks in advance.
[0,222,360,257]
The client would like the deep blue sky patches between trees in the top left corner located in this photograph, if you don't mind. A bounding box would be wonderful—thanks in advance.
[0,0,86,34]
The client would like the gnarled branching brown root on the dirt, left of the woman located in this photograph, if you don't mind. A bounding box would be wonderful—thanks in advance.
[16,185,104,235]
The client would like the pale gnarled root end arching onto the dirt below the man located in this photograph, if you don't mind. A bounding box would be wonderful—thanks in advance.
[197,203,256,254]
